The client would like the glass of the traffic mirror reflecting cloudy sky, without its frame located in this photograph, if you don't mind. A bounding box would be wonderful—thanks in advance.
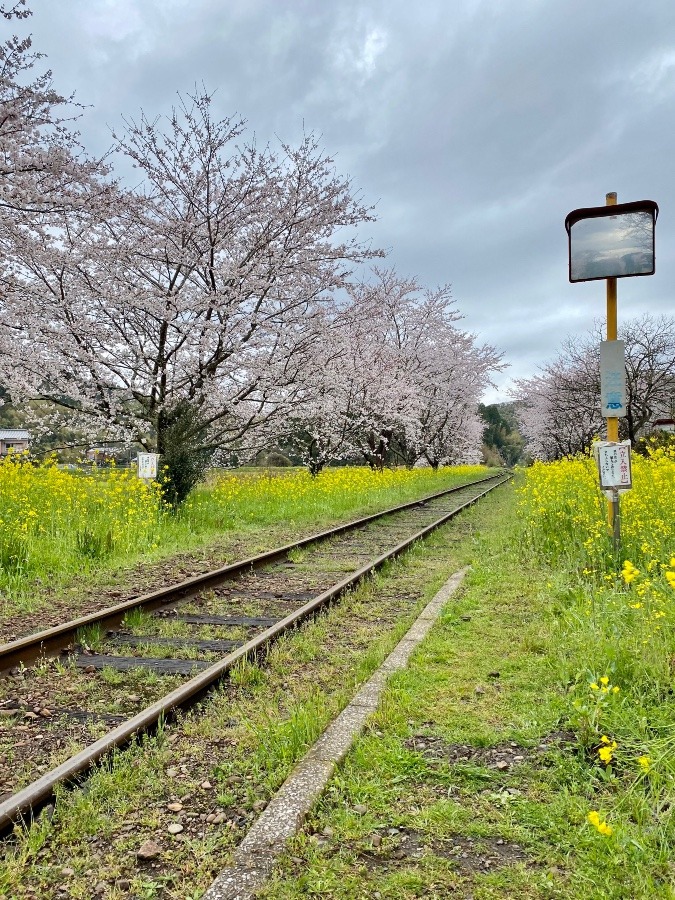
[571,212,654,281]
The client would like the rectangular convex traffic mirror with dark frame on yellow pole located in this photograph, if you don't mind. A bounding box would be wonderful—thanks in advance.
[565,200,659,281]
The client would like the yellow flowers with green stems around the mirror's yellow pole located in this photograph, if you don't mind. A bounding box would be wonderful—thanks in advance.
[520,449,675,856]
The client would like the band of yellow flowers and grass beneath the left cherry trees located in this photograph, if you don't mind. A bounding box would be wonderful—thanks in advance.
[0,455,488,607]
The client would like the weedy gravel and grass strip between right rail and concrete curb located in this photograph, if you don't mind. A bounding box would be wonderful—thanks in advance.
[0,488,496,900]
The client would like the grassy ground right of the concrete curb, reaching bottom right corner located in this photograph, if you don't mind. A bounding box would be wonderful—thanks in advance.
[261,469,675,900]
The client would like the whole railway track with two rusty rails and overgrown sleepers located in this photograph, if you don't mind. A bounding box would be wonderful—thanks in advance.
[0,475,507,830]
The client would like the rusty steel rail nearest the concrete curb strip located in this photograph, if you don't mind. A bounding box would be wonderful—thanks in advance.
[0,474,512,833]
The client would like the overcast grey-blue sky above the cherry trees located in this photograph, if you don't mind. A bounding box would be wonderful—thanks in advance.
[23,0,675,400]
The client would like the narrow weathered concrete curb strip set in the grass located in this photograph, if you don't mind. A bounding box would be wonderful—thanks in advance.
[202,569,466,900]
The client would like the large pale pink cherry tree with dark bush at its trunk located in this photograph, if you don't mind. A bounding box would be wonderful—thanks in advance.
[0,94,377,500]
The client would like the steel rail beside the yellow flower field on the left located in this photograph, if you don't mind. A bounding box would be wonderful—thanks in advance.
[0,472,504,673]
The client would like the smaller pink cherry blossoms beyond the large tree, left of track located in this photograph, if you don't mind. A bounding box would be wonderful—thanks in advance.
[286,269,500,471]
